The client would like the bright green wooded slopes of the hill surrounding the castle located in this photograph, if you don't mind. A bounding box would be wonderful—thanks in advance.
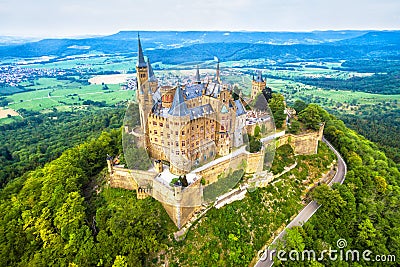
[0,105,400,266]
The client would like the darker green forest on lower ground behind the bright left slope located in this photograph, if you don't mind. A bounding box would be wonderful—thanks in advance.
[0,108,124,188]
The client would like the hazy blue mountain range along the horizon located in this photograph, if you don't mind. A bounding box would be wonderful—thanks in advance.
[0,31,400,63]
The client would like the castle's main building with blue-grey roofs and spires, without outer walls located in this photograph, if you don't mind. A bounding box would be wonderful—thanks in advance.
[136,36,265,175]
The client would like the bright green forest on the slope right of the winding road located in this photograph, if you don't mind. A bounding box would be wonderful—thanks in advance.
[276,106,400,266]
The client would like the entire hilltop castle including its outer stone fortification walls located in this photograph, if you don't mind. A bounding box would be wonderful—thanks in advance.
[107,35,321,229]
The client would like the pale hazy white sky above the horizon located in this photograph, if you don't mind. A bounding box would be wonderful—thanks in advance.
[0,0,400,37]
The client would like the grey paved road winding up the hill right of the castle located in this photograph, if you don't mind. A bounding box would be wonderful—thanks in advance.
[255,137,347,267]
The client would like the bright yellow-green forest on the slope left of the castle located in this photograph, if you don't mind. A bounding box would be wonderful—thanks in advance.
[0,130,173,266]
